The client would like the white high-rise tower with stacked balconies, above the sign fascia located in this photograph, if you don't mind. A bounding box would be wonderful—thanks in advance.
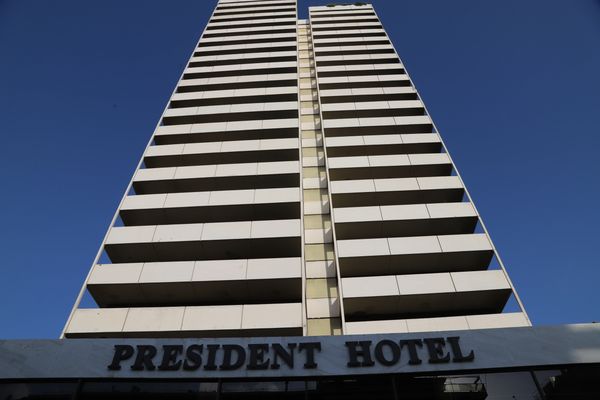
[64,0,530,338]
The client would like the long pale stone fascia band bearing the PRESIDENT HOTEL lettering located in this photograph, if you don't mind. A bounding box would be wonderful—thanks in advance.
[0,324,600,380]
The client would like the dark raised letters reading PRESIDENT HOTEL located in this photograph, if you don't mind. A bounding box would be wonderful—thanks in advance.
[108,336,475,371]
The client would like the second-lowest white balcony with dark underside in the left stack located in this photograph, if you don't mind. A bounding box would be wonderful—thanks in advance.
[87,258,302,307]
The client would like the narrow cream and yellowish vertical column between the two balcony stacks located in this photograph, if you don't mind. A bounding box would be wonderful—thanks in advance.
[298,21,341,335]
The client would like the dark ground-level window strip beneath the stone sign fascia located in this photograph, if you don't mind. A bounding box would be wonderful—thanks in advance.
[0,366,600,400]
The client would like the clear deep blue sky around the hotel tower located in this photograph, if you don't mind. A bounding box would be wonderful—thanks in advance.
[0,0,600,338]
